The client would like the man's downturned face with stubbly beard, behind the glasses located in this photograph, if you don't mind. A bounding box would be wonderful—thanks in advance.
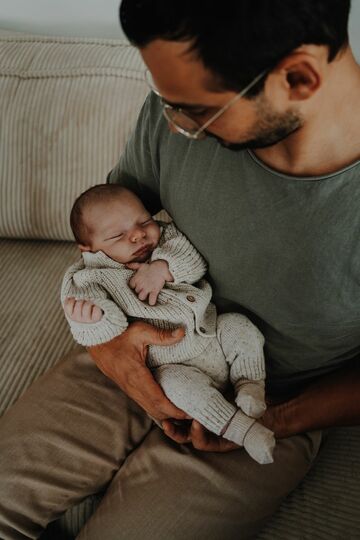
[140,39,302,150]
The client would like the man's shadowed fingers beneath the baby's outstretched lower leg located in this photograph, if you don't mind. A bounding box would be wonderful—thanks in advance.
[162,420,239,452]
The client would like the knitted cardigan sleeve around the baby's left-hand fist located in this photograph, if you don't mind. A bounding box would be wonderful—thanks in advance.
[61,263,128,347]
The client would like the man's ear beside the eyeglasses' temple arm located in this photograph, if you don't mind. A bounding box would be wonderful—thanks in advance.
[276,51,323,101]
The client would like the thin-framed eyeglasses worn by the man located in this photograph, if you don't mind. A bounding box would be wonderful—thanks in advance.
[144,69,269,141]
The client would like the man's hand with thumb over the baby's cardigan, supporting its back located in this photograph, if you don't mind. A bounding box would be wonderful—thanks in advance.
[88,322,188,421]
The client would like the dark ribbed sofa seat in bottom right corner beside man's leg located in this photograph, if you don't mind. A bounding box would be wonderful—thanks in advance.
[257,427,360,540]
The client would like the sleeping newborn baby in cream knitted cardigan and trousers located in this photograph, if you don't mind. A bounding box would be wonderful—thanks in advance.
[61,184,275,463]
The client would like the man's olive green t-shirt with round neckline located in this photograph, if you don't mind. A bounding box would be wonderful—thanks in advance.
[108,93,360,392]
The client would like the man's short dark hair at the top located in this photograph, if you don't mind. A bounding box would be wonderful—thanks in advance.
[120,0,350,96]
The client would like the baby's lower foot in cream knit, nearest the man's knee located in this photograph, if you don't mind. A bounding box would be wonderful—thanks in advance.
[223,410,275,464]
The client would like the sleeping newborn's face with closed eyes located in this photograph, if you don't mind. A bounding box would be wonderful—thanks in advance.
[84,193,160,264]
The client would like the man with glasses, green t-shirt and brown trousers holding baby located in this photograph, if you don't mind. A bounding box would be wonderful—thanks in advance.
[0,0,360,540]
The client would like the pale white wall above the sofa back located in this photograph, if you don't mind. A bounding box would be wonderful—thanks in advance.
[0,0,360,62]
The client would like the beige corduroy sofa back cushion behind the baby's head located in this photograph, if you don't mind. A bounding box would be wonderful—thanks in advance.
[0,30,148,240]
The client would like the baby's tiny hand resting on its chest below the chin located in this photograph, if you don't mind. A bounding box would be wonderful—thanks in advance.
[126,260,173,306]
